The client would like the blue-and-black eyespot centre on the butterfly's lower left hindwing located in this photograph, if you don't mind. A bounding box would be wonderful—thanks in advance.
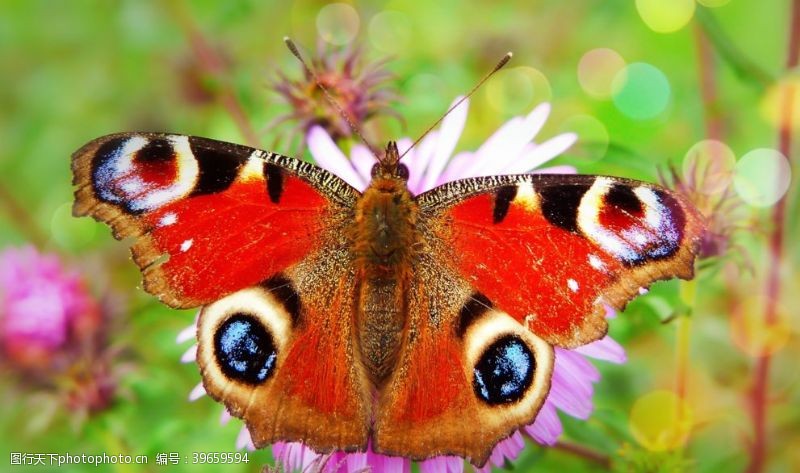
[214,313,278,384]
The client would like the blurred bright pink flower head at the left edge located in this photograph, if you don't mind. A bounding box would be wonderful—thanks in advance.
[0,246,100,369]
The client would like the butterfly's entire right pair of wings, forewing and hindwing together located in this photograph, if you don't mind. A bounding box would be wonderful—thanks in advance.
[375,175,702,466]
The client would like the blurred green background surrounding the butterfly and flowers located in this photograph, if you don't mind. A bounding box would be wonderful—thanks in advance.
[0,0,800,472]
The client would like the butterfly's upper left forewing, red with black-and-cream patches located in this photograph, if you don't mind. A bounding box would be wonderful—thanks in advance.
[73,133,358,307]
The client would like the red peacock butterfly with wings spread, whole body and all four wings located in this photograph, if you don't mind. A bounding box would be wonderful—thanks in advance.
[72,133,702,466]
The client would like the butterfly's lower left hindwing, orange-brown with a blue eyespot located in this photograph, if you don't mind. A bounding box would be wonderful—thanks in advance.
[197,246,371,452]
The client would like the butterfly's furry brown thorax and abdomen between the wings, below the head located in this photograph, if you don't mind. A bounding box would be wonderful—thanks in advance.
[354,178,418,386]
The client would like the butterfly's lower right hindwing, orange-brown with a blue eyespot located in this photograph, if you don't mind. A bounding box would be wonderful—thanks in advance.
[374,253,554,466]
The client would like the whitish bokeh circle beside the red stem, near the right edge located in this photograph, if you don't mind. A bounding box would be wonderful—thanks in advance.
[733,148,792,207]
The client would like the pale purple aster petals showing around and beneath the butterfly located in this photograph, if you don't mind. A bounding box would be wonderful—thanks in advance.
[178,101,625,473]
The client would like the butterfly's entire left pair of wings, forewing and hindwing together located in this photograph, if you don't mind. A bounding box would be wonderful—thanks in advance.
[73,133,370,450]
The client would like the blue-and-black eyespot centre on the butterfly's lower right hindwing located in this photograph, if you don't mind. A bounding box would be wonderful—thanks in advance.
[472,335,536,405]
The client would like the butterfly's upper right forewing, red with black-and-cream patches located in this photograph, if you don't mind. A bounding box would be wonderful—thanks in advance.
[417,174,702,347]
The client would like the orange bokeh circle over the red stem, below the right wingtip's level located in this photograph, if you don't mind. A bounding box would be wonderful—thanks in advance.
[730,296,791,357]
